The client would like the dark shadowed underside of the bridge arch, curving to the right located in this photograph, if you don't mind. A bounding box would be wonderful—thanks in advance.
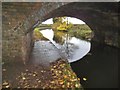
[39,2,119,46]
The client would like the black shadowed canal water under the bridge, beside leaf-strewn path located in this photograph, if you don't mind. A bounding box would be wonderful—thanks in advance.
[71,43,119,88]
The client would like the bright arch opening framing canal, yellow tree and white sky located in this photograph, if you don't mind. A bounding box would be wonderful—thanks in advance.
[33,16,93,63]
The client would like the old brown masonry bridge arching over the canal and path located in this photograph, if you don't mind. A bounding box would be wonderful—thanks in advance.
[2,2,120,62]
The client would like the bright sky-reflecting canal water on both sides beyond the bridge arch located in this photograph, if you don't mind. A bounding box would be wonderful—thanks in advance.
[40,29,91,63]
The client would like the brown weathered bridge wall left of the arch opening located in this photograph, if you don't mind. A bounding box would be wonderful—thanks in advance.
[2,2,68,63]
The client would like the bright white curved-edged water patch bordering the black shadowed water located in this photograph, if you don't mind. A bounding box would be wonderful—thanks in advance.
[68,37,91,62]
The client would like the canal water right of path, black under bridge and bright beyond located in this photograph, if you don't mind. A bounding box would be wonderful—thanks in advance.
[39,29,119,88]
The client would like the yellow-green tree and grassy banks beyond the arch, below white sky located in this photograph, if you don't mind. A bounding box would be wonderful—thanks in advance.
[34,17,93,44]
